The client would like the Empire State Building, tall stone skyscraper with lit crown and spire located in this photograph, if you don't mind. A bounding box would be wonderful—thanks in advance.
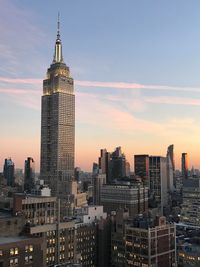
[40,20,75,198]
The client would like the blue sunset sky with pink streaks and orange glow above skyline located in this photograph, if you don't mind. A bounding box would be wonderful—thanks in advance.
[0,0,200,171]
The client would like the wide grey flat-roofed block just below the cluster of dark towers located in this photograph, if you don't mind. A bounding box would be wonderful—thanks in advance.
[101,185,148,217]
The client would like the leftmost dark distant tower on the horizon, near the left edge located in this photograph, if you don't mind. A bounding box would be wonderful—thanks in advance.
[3,158,15,186]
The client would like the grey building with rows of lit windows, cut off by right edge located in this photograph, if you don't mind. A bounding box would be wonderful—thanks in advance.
[180,178,200,226]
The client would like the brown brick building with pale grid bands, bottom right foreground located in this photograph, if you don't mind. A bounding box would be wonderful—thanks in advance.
[125,217,176,267]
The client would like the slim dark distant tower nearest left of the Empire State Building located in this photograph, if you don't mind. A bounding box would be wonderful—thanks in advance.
[24,157,35,193]
